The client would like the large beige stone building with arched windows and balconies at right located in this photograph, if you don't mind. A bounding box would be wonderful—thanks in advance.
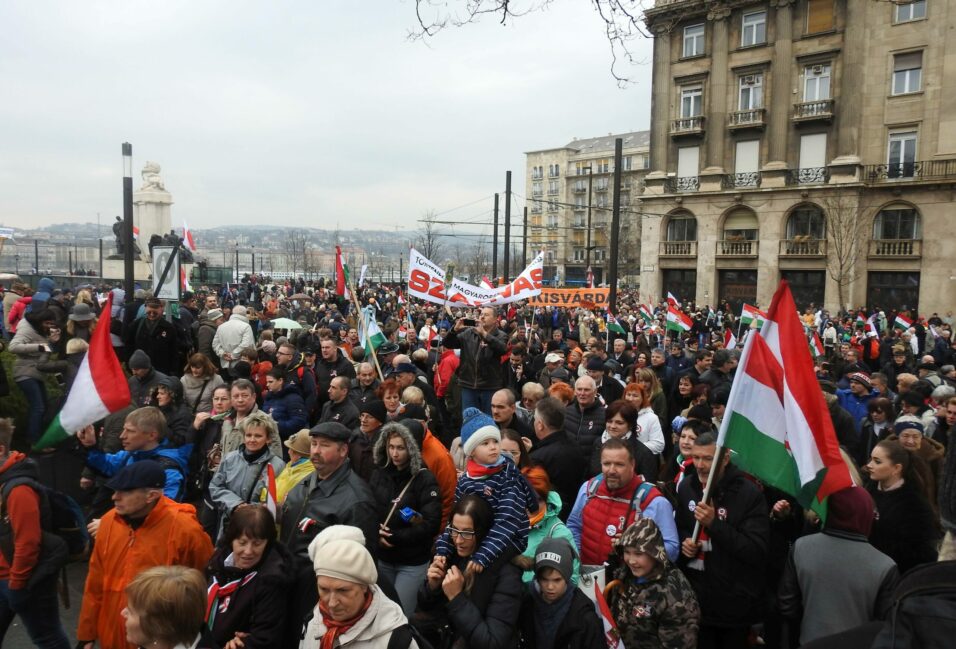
[641,0,956,313]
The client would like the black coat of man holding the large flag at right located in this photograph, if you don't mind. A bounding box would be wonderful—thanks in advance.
[675,464,770,627]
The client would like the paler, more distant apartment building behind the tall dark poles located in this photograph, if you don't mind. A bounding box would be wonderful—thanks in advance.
[525,131,650,286]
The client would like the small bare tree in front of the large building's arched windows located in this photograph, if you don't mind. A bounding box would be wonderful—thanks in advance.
[821,191,868,309]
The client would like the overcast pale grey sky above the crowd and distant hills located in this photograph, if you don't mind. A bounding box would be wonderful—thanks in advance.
[0,0,651,234]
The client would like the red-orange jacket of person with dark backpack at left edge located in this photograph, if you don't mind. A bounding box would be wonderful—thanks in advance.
[0,451,43,590]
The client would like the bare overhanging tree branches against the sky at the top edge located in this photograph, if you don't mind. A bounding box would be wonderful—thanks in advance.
[408,0,654,83]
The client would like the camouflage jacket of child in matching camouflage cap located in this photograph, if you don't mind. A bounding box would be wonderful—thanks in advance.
[608,564,700,649]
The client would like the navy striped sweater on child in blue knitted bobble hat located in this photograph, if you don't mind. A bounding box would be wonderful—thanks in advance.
[435,459,538,568]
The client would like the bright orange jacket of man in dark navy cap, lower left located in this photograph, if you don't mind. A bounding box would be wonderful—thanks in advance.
[76,496,213,649]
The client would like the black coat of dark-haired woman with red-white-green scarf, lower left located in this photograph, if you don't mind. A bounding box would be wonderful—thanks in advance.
[206,543,293,649]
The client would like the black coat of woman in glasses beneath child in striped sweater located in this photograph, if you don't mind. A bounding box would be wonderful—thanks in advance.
[416,552,522,649]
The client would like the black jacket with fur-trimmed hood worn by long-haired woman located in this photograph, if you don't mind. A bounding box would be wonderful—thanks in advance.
[369,422,442,566]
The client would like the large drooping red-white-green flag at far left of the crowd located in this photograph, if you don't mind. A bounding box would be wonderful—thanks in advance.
[33,293,131,450]
